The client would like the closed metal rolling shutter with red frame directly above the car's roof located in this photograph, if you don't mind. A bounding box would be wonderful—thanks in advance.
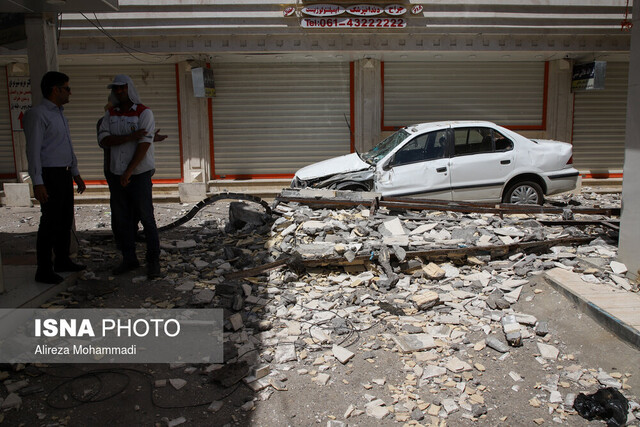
[384,62,544,126]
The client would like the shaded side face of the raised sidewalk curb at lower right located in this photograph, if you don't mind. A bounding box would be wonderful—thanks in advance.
[543,272,640,349]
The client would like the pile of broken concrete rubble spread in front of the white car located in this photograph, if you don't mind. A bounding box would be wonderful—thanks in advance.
[114,191,638,426]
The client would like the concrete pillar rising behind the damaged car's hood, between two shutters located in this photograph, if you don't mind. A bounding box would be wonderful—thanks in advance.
[351,59,382,153]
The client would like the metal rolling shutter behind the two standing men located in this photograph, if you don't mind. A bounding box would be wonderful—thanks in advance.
[60,64,182,180]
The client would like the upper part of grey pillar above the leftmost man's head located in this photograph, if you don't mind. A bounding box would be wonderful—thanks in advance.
[25,13,58,105]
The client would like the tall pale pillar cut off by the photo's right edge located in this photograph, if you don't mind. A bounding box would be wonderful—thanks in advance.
[618,1,640,278]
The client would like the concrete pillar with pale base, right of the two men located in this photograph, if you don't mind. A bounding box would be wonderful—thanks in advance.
[178,62,211,183]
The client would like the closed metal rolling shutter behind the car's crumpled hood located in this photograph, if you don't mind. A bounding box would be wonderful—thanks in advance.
[213,63,350,176]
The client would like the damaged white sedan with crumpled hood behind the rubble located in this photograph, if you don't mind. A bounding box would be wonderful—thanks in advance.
[291,121,579,204]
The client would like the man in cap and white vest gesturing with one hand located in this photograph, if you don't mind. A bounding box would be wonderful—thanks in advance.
[98,74,161,279]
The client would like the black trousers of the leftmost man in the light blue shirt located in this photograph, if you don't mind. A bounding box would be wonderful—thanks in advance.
[36,168,73,271]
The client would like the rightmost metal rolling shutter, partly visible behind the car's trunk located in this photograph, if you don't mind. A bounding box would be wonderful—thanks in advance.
[573,62,629,173]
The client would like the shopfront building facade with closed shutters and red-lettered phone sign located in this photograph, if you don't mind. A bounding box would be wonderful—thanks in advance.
[0,0,637,183]
